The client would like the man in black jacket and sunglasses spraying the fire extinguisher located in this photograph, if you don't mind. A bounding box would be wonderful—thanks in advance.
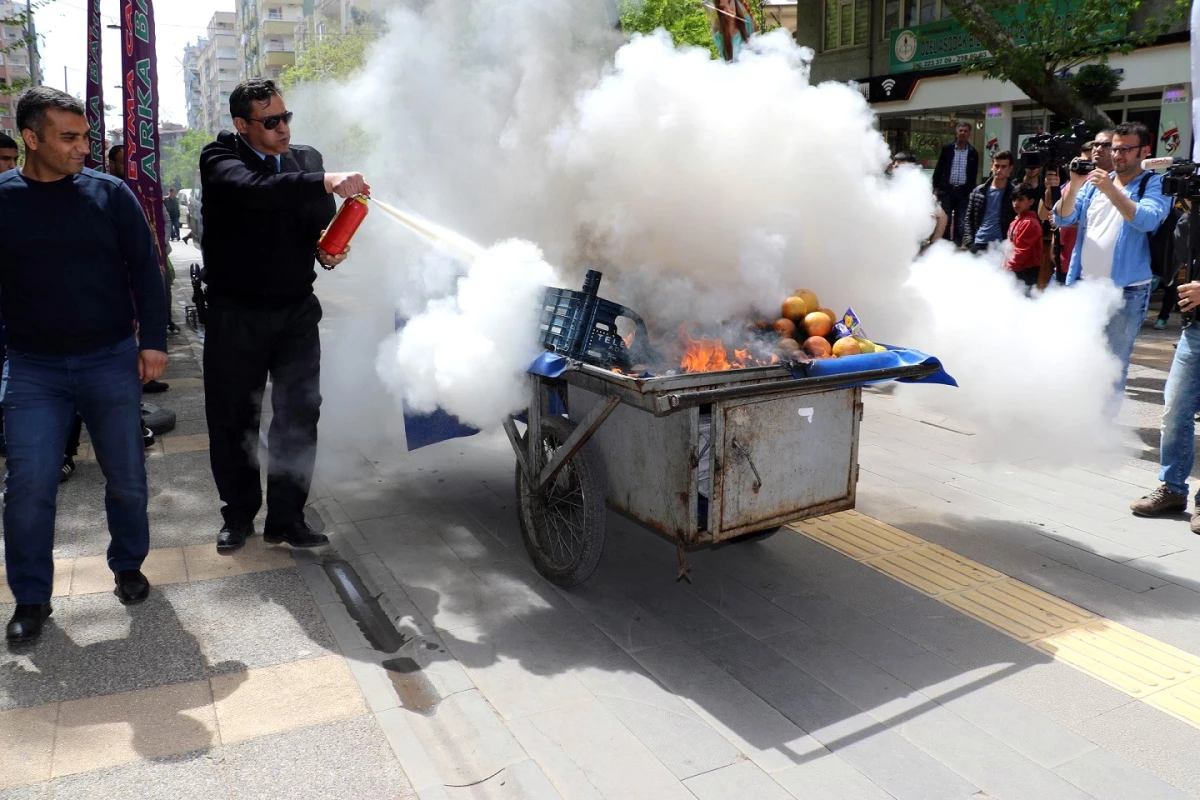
[200,78,368,552]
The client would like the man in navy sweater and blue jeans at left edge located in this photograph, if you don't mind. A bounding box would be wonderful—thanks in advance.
[0,86,167,642]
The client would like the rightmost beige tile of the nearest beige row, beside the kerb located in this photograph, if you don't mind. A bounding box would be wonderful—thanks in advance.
[211,656,367,745]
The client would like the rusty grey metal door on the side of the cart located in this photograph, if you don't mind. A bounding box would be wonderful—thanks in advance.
[709,387,862,541]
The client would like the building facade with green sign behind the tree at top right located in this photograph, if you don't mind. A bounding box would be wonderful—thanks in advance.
[796,0,1192,168]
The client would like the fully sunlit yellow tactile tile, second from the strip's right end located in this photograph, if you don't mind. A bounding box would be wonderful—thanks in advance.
[1033,619,1200,697]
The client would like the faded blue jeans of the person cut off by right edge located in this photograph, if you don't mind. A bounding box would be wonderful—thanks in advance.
[1158,323,1200,494]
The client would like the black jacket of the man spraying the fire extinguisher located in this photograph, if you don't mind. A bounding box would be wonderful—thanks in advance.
[200,131,335,308]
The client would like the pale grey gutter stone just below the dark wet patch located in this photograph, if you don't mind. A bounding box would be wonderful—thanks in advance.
[400,690,528,790]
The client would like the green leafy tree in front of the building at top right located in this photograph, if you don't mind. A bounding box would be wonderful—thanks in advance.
[942,0,1190,128]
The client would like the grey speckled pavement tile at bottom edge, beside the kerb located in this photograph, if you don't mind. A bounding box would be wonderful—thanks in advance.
[224,715,416,800]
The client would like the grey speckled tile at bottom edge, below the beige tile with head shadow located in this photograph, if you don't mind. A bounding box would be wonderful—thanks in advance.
[49,748,229,800]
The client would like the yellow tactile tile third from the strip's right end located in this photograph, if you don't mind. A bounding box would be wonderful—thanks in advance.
[941,573,1099,643]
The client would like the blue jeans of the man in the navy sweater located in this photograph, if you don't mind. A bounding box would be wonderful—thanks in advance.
[0,336,150,603]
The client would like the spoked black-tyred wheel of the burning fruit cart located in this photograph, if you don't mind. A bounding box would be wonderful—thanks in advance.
[516,416,605,587]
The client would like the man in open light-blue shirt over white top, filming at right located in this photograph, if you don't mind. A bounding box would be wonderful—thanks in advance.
[1054,122,1170,416]
